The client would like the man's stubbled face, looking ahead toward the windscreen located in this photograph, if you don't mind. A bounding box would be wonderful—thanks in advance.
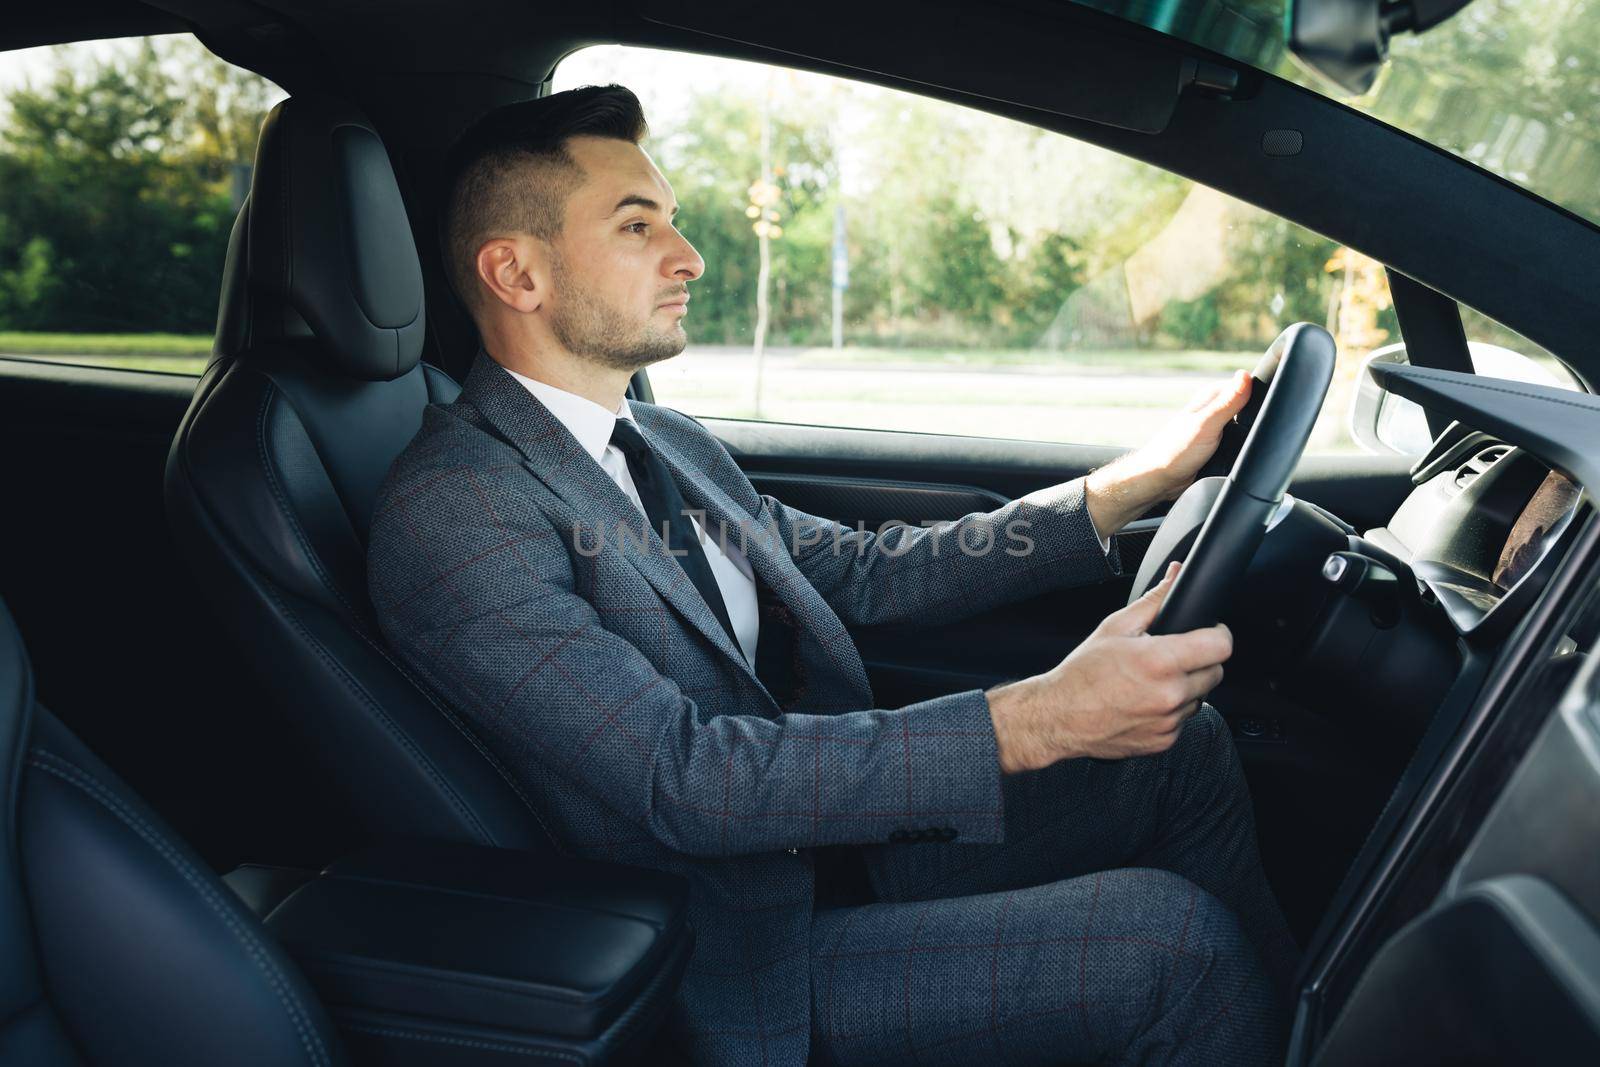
[549,138,706,371]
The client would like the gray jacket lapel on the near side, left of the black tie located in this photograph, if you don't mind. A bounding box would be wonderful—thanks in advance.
[461,350,761,691]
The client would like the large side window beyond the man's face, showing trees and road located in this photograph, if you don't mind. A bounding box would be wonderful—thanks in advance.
[554,46,1398,451]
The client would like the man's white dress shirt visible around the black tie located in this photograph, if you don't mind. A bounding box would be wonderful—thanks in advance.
[509,371,762,665]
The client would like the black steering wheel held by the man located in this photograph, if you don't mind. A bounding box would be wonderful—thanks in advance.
[1128,323,1336,633]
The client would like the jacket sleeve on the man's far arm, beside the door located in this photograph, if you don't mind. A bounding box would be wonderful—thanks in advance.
[762,478,1120,625]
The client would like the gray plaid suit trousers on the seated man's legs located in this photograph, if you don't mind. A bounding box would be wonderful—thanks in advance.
[811,707,1296,1067]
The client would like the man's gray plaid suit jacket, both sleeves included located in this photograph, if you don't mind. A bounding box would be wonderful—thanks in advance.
[368,352,1112,1067]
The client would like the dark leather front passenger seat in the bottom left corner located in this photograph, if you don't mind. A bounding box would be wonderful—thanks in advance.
[0,605,346,1067]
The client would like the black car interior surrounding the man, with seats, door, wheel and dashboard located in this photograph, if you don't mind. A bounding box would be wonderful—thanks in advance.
[0,0,1600,1064]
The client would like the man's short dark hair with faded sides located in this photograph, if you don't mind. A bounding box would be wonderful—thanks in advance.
[442,85,648,310]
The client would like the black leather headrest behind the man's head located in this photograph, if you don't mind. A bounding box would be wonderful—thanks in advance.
[244,96,424,381]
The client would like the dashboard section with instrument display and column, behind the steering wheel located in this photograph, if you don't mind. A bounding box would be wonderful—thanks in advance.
[1229,363,1600,726]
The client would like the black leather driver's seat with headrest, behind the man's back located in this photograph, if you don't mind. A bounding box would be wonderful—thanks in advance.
[166,98,555,862]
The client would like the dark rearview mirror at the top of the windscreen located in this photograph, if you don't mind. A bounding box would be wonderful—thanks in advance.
[1285,0,1472,96]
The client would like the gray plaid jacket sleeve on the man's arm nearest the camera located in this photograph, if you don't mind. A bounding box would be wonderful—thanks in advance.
[368,460,1003,856]
